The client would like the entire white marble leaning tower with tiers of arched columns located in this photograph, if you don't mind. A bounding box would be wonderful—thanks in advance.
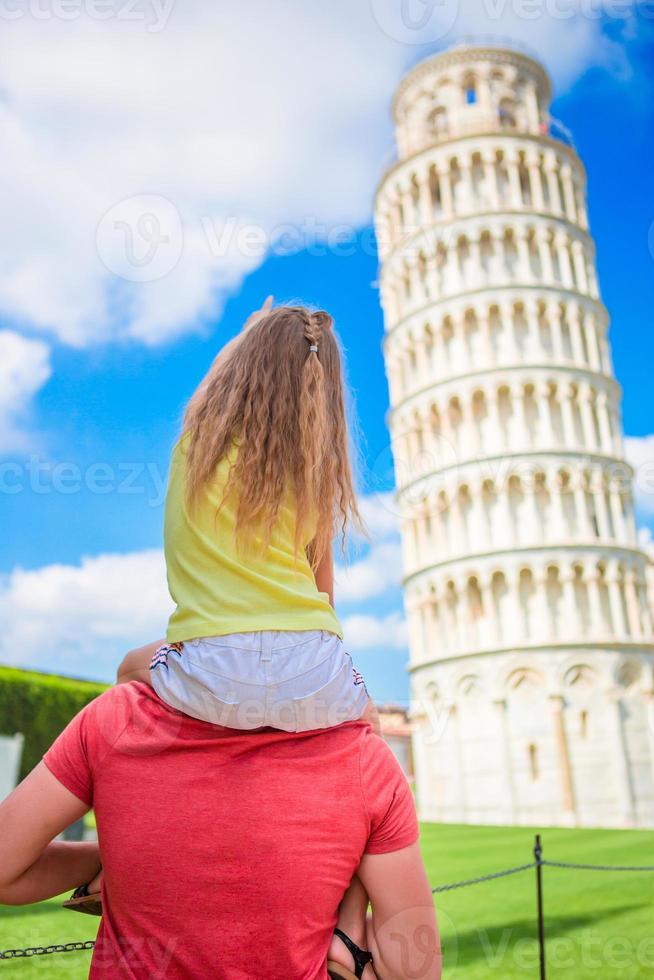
[376,47,654,826]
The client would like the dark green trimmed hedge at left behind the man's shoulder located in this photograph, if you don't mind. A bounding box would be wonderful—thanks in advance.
[0,667,107,777]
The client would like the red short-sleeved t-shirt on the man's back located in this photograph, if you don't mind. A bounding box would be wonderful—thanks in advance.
[45,683,418,980]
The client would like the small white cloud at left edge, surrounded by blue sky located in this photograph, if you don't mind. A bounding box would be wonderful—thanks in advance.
[0,330,51,453]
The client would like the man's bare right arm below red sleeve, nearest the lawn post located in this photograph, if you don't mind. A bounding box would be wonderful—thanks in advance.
[357,843,442,980]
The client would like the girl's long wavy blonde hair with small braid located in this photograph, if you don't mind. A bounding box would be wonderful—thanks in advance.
[184,306,363,568]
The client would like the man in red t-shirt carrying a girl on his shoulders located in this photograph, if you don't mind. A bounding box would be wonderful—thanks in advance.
[0,683,441,980]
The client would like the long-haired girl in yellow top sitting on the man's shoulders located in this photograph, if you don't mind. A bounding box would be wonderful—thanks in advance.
[102,297,378,978]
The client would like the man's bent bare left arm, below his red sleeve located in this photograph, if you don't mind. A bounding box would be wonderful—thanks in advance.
[0,762,100,905]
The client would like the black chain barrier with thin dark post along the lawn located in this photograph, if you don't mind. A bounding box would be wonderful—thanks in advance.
[0,835,654,980]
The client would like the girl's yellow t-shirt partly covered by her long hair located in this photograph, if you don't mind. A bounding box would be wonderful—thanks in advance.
[164,439,343,643]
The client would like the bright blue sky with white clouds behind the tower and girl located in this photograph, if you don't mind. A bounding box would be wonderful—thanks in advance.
[0,0,654,700]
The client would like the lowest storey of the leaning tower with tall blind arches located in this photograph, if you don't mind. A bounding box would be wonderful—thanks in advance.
[412,645,654,828]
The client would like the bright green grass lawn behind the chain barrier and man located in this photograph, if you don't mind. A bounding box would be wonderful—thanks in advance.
[0,824,654,980]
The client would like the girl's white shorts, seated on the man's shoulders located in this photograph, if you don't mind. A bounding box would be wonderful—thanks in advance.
[150,630,368,732]
